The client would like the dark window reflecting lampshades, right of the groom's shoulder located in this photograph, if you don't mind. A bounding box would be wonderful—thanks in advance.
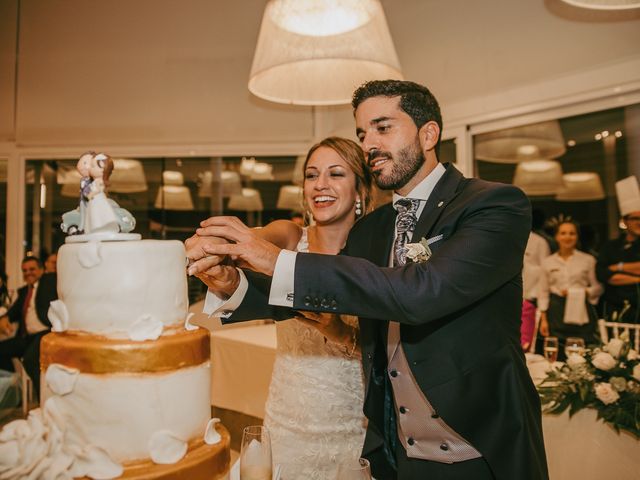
[474,105,640,255]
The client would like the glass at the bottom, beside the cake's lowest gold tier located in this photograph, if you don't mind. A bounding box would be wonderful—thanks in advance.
[240,425,273,480]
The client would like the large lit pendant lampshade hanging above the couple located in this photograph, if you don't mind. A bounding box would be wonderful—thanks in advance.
[249,0,402,105]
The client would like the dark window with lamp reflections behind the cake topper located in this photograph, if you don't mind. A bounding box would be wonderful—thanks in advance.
[22,157,302,300]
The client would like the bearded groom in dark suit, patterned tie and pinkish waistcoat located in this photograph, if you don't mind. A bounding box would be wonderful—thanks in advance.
[186,80,548,480]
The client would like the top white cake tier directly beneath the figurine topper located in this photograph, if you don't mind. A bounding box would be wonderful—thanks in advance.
[58,240,188,338]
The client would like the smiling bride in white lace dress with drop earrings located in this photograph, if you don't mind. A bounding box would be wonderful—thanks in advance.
[248,137,371,480]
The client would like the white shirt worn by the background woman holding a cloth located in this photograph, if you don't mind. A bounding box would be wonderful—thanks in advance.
[538,250,604,312]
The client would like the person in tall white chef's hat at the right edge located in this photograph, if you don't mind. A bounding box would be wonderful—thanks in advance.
[596,176,640,323]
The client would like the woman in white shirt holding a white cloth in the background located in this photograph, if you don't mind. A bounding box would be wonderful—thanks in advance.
[538,220,603,359]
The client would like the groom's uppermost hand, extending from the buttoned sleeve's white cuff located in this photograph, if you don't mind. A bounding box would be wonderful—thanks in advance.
[196,217,281,276]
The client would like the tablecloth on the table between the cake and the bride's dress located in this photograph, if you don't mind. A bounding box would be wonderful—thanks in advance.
[211,324,276,418]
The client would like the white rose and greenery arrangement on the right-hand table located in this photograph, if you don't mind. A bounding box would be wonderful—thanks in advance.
[538,334,640,438]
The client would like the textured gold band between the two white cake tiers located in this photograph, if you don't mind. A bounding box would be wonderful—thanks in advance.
[40,328,210,374]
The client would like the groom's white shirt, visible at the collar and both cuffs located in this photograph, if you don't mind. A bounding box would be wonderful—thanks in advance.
[203,163,453,317]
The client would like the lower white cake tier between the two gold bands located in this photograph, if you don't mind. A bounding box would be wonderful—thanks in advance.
[42,362,211,463]
